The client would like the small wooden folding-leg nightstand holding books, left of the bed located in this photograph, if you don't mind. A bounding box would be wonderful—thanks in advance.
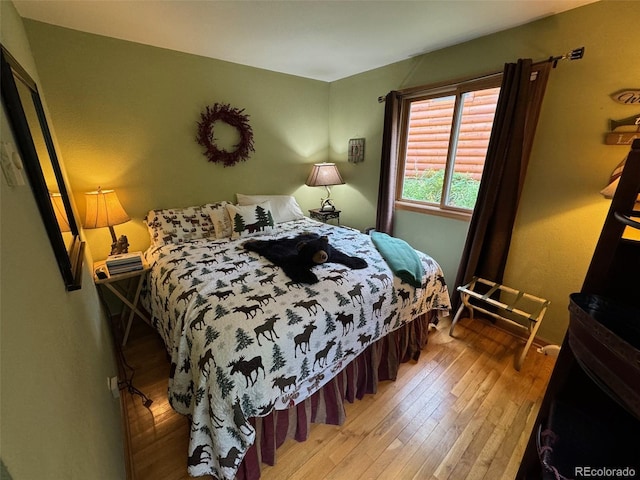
[93,261,151,347]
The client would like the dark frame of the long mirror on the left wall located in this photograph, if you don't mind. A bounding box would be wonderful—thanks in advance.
[0,45,85,291]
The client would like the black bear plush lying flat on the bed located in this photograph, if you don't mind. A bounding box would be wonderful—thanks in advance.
[244,233,367,283]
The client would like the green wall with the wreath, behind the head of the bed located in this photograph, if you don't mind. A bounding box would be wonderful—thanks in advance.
[21,21,330,258]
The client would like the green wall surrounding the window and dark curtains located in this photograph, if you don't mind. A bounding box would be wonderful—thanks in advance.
[330,1,640,343]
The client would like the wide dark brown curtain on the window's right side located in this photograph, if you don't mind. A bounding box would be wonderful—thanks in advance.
[452,59,551,312]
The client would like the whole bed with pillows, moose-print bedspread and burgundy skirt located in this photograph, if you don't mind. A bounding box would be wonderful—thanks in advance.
[141,195,450,480]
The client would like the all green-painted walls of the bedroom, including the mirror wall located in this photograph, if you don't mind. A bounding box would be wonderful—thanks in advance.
[0,1,640,479]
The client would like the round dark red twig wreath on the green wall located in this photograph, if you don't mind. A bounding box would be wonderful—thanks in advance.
[196,103,255,167]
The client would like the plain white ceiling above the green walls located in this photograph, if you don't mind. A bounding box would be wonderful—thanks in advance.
[13,0,596,81]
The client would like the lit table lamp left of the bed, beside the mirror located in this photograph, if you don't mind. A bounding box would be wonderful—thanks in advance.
[84,187,131,255]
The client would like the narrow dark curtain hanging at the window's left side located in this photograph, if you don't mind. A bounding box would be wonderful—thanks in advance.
[376,91,400,235]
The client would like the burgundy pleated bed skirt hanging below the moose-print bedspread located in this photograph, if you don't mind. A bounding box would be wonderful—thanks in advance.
[236,312,436,480]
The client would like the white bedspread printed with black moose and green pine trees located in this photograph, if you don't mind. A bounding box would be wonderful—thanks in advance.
[143,219,450,479]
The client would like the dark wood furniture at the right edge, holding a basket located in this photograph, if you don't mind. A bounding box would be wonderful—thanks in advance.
[516,140,640,480]
